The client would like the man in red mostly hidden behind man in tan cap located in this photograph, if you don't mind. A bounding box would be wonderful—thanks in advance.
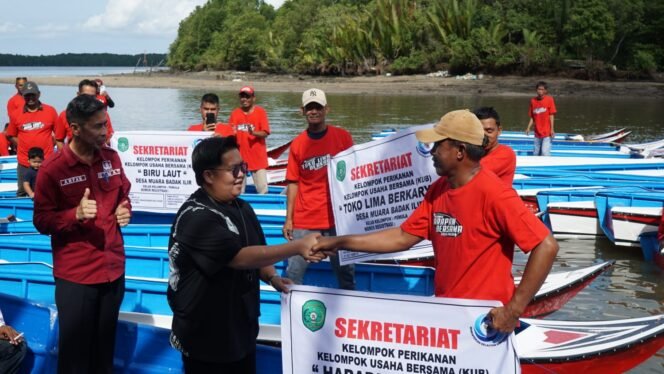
[473,107,516,186]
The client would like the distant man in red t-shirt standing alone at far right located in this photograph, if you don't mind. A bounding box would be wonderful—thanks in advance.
[526,81,556,156]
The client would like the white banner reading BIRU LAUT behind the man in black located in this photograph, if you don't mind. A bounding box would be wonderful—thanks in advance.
[111,131,210,213]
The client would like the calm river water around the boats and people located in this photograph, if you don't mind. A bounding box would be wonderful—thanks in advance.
[0,68,664,373]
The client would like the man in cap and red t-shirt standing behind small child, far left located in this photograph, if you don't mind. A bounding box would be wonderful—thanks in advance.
[7,81,58,197]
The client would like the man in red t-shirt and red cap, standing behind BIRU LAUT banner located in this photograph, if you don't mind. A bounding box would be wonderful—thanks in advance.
[228,86,270,194]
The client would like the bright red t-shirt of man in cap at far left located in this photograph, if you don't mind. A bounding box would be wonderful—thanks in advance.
[7,104,58,167]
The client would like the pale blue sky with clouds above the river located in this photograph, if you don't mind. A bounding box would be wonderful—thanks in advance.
[0,0,284,55]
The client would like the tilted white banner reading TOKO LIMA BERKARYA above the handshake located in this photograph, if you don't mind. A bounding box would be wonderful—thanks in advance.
[327,125,438,264]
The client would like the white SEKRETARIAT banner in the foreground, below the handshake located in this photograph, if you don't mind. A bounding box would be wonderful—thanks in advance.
[281,286,521,374]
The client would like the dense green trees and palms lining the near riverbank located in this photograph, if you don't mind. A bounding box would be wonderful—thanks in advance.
[168,0,664,79]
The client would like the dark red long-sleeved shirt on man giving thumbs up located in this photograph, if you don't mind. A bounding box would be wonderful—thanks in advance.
[33,146,131,284]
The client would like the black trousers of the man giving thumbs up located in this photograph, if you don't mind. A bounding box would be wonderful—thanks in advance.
[55,275,124,374]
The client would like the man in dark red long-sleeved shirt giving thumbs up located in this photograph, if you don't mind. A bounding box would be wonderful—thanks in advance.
[33,95,131,373]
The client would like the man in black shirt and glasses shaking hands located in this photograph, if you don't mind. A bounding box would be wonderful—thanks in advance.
[168,136,322,373]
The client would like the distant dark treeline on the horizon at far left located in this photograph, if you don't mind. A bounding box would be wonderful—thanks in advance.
[0,53,166,66]
